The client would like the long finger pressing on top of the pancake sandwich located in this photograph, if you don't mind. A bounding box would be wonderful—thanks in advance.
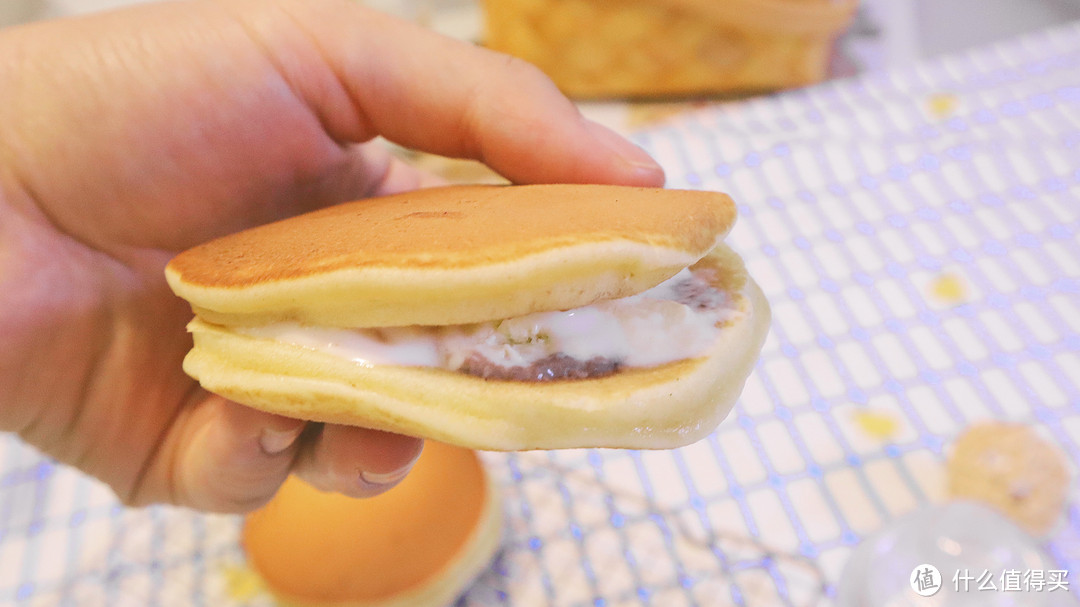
[238,0,663,186]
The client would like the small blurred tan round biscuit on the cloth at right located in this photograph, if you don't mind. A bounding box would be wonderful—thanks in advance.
[946,421,1069,537]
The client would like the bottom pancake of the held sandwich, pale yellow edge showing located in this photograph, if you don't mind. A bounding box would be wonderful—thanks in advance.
[184,246,770,450]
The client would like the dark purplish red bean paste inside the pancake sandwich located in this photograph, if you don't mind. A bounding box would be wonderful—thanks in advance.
[457,270,726,381]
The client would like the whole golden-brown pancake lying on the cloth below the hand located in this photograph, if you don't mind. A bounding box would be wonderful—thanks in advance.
[243,441,502,607]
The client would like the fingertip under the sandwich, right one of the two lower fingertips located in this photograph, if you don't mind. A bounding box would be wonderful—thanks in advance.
[296,424,423,497]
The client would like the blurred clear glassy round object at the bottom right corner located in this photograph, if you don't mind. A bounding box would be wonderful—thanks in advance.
[836,502,1062,607]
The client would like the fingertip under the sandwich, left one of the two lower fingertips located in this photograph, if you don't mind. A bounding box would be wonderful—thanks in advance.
[132,395,305,512]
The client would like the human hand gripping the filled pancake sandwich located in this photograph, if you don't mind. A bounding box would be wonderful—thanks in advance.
[0,0,663,512]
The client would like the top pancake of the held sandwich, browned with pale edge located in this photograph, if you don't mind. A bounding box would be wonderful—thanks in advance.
[165,185,734,327]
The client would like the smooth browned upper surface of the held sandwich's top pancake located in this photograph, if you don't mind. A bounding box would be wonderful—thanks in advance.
[170,185,734,288]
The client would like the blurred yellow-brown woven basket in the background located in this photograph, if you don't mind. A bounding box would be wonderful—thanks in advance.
[483,0,858,98]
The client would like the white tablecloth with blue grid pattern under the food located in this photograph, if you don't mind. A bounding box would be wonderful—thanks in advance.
[0,18,1080,607]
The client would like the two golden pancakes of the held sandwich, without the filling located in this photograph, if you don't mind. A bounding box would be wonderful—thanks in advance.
[166,186,770,450]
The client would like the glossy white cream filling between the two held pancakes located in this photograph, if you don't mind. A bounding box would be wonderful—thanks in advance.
[235,269,739,370]
